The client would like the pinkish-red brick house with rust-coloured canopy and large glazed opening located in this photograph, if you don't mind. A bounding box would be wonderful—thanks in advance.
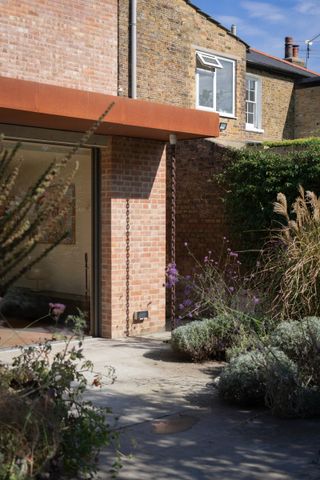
[0,0,219,337]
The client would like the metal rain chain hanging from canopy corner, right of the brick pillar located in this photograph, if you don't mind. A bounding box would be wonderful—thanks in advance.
[170,145,176,330]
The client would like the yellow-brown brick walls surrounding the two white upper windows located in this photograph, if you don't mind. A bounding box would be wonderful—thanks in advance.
[119,0,293,141]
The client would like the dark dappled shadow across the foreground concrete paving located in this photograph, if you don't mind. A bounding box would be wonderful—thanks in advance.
[95,386,320,480]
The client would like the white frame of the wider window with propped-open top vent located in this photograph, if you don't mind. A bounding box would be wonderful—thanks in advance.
[196,51,236,118]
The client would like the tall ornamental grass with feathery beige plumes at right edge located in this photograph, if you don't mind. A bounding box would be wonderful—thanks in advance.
[259,187,320,320]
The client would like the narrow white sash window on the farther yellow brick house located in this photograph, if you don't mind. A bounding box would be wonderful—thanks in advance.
[246,75,263,133]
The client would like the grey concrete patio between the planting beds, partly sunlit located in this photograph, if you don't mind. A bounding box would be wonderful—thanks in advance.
[0,336,320,480]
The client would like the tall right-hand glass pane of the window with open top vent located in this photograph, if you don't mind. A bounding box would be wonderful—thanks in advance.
[216,58,234,115]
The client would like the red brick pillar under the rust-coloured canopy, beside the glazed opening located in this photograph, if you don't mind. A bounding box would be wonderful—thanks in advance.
[102,137,166,337]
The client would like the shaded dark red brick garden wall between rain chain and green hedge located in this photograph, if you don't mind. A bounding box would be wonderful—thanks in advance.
[167,140,229,274]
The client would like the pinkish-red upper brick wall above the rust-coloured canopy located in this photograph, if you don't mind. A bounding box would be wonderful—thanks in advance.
[0,0,117,95]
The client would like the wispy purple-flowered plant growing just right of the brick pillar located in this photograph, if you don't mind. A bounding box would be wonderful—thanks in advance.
[166,237,260,323]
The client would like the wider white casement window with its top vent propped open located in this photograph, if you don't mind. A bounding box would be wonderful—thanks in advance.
[196,52,235,117]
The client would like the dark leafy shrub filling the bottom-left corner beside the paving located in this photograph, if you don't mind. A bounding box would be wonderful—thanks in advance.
[0,340,118,480]
